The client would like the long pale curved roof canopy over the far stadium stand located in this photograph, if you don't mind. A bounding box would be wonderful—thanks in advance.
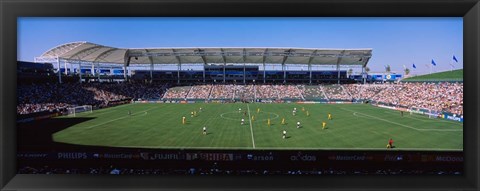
[35,41,372,66]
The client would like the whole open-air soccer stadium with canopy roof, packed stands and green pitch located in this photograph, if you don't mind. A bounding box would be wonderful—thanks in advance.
[17,42,463,151]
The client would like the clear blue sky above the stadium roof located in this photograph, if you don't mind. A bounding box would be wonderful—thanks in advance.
[17,17,463,74]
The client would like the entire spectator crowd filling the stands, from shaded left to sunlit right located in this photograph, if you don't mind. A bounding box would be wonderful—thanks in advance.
[17,82,463,115]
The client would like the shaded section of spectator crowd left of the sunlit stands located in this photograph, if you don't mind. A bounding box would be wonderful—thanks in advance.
[17,83,168,114]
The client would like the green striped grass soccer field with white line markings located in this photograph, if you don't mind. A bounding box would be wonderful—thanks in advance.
[52,103,463,150]
